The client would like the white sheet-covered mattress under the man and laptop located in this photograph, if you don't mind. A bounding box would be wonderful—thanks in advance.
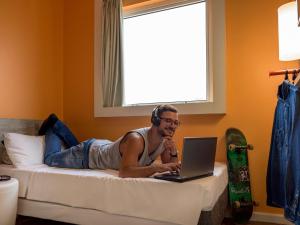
[0,163,228,225]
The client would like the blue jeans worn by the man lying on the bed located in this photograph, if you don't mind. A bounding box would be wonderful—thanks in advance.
[44,120,94,169]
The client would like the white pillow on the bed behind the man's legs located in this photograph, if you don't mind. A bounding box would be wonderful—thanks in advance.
[4,133,45,167]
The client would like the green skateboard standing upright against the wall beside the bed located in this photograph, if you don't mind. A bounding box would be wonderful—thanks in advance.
[226,128,253,223]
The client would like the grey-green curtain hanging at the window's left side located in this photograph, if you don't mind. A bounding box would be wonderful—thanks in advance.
[102,0,123,107]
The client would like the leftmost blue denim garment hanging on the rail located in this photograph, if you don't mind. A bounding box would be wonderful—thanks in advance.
[267,82,291,208]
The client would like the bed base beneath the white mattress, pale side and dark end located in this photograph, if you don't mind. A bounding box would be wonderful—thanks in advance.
[17,186,228,225]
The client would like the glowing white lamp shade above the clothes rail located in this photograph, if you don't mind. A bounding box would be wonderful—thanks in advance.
[278,1,300,61]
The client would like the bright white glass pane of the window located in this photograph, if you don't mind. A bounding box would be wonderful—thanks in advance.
[124,2,208,105]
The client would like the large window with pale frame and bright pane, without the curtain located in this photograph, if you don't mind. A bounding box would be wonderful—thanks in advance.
[94,0,225,117]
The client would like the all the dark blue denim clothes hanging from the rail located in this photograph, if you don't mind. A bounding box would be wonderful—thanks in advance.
[267,81,300,225]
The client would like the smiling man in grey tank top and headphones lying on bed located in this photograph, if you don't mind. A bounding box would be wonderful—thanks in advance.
[39,105,180,177]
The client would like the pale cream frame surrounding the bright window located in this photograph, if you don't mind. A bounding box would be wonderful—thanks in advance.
[94,0,226,117]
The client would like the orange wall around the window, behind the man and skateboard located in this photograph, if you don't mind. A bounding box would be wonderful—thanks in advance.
[64,0,298,213]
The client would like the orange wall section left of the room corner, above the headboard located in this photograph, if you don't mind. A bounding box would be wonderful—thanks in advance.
[0,0,63,119]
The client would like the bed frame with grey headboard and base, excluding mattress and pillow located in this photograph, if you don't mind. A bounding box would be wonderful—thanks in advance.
[0,119,228,225]
